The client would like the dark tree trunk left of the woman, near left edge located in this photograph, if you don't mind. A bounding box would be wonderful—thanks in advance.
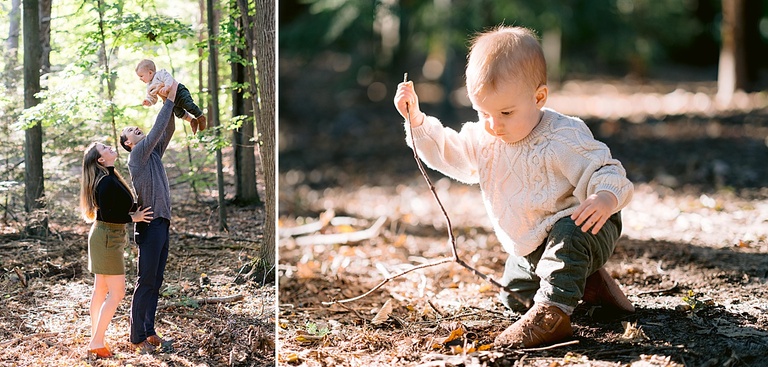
[23,0,48,235]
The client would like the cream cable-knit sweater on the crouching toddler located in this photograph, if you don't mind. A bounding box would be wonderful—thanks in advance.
[405,108,634,256]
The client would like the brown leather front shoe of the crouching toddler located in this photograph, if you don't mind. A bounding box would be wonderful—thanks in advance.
[493,304,573,348]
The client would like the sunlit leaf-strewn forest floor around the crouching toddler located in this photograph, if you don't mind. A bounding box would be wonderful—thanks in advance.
[278,75,768,366]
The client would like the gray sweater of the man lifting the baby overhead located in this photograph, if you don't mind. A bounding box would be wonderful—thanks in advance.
[128,100,176,220]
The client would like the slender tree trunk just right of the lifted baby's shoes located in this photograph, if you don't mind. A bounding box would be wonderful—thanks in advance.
[206,0,229,231]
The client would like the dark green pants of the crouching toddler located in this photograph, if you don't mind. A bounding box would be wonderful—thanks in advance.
[499,212,621,313]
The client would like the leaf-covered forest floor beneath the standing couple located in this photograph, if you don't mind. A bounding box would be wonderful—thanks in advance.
[0,178,276,367]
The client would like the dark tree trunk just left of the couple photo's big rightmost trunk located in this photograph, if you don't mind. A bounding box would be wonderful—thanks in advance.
[232,0,261,205]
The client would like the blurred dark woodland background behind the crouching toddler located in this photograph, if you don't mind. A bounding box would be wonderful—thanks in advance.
[278,0,768,196]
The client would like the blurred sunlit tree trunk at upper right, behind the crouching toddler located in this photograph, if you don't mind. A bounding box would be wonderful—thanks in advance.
[717,0,747,105]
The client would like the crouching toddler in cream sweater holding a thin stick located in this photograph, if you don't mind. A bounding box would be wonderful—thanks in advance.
[394,26,634,348]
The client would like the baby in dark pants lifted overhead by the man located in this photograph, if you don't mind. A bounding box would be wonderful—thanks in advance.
[136,59,206,134]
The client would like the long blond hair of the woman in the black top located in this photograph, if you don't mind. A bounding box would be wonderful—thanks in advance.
[80,142,135,223]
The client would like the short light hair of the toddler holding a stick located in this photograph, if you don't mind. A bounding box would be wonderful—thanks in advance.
[466,26,547,96]
